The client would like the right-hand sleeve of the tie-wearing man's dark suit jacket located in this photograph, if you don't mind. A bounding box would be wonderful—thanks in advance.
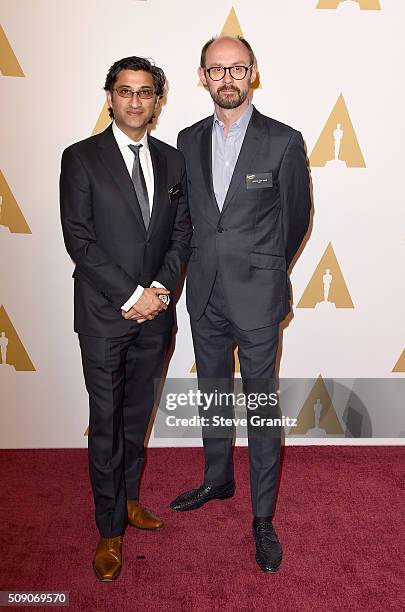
[155,161,192,292]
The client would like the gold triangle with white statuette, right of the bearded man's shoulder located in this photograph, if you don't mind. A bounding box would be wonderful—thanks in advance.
[309,94,366,168]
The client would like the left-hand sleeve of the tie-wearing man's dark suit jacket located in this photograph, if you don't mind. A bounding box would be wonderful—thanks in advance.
[60,149,138,311]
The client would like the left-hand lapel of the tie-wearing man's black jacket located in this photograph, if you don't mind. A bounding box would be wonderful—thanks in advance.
[98,126,146,232]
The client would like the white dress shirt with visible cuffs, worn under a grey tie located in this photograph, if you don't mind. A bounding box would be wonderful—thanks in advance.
[112,121,164,312]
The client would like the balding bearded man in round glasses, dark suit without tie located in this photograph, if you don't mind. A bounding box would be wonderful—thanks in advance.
[171,37,311,572]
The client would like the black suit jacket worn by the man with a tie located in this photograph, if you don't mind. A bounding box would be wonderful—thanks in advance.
[60,126,191,337]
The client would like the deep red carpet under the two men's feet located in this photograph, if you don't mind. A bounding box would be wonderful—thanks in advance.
[0,446,405,612]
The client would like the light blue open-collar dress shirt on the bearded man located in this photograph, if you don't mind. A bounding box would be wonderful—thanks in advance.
[212,104,253,210]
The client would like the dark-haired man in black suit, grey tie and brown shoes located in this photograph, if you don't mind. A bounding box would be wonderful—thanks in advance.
[60,57,191,581]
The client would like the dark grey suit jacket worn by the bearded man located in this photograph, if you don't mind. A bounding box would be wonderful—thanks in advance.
[178,108,311,330]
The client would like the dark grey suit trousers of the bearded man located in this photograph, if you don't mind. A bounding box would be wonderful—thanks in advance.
[191,273,280,517]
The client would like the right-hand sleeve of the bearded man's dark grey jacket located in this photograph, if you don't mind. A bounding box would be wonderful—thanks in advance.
[279,132,311,268]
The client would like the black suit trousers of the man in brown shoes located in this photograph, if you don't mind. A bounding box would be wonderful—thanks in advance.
[79,324,171,538]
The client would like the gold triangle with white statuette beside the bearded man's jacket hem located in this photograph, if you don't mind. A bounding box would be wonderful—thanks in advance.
[297,243,354,310]
